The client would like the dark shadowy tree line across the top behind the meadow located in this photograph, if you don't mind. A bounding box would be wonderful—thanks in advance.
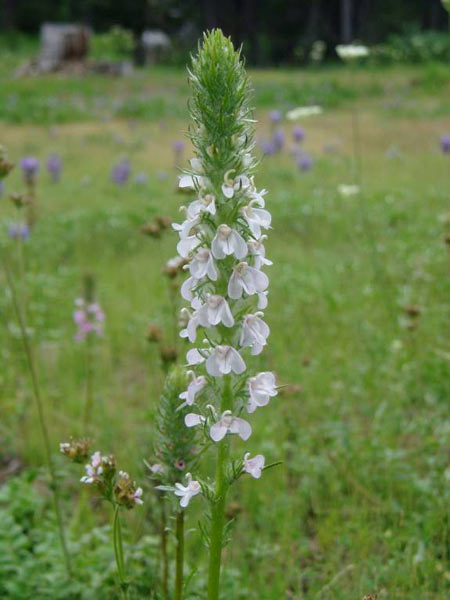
[0,0,448,64]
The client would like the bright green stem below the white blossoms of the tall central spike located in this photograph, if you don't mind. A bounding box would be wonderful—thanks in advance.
[208,375,232,600]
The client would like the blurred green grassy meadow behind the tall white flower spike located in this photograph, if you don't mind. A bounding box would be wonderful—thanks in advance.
[0,54,450,600]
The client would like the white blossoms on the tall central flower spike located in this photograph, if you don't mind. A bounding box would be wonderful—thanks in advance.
[173,151,277,507]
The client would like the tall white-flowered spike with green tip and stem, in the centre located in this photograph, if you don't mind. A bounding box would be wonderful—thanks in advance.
[174,30,277,600]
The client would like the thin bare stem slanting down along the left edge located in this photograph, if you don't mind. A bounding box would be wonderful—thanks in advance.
[1,254,72,578]
